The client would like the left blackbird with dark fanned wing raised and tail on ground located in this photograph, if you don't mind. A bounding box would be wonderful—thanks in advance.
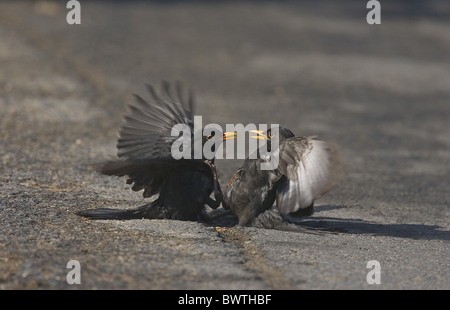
[77,82,226,220]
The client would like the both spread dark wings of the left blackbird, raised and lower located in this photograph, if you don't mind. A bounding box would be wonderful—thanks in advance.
[99,82,199,197]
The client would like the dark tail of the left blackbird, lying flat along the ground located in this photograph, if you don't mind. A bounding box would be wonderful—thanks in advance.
[76,200,169,220]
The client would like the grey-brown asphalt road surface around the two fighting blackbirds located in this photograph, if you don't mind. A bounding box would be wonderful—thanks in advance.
[0,1,450,289]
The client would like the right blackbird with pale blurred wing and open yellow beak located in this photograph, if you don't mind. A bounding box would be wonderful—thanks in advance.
[222,127,340,231]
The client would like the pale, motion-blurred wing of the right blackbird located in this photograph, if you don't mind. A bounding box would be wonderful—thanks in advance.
[277,137,340,214]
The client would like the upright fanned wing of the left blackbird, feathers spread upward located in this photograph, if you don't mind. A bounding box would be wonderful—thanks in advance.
[117,82,194,160]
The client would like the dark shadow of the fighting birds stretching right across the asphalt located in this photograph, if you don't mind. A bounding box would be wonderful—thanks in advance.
[206,205,450,241]
